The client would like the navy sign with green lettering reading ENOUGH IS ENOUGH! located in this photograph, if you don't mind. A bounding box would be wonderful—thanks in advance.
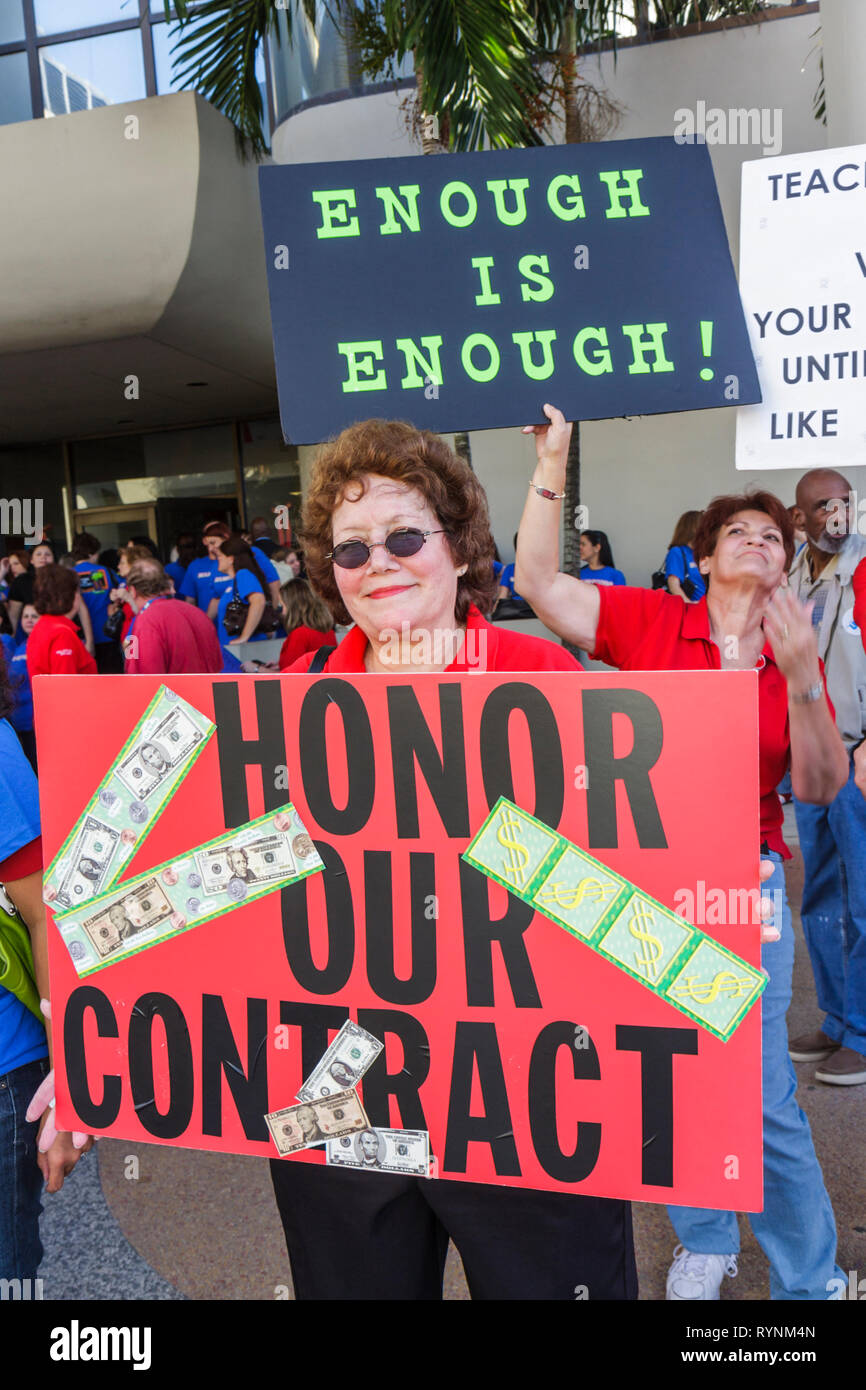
[260,138,760,443]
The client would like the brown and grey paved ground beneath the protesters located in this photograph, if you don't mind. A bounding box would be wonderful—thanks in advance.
[40,808,866,1300]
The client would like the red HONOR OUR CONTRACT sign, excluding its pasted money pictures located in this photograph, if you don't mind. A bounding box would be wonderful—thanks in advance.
[35,671,762,1211]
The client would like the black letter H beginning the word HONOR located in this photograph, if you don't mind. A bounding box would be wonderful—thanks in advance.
[213,681,289,830]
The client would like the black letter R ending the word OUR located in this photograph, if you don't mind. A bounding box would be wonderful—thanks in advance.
[460,859,541,1009]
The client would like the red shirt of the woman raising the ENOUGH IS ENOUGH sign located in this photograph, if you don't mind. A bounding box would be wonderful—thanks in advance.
[592,588,824,859]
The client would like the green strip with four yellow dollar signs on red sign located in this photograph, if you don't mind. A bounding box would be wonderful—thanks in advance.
[463,796,767,1043]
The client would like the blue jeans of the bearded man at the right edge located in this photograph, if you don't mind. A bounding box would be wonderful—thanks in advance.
[794,762,866,1052]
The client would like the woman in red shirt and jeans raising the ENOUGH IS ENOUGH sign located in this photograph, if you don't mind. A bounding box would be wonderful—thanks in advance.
[517,406,848,1301]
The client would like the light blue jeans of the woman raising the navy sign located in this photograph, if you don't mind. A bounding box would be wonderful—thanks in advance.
[667,853,845,1301]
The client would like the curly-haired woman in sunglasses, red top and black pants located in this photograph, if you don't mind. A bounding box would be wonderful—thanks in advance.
[271,420,637,1300]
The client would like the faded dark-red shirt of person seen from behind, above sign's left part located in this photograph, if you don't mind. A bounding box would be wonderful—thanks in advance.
[125,595,222,676]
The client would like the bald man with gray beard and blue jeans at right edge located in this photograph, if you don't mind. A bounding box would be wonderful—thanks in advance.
[788,468,866,1086]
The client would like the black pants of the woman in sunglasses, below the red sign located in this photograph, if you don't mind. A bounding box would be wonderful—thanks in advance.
[271,1158,638,1302]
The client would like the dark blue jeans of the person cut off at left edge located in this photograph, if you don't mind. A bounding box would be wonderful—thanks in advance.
[0,1061,49,1279]
